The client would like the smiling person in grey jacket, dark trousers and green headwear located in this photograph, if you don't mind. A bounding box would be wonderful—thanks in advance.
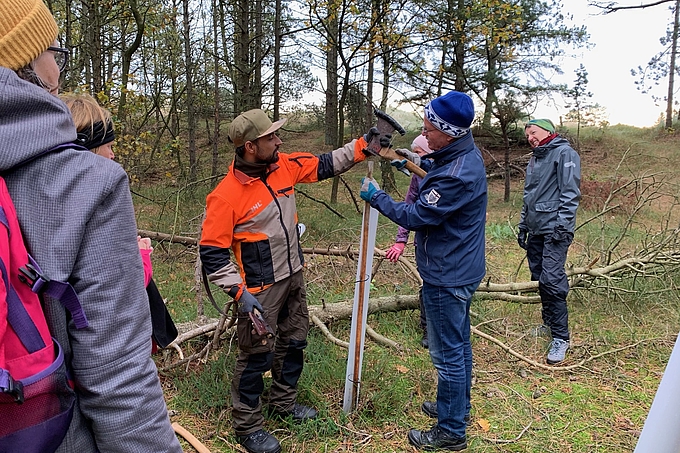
[517,119,581,365]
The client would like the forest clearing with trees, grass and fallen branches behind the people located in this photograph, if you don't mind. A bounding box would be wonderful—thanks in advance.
[48,0,680,452]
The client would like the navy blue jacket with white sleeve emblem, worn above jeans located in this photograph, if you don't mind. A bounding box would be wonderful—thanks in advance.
[371,133,487,287]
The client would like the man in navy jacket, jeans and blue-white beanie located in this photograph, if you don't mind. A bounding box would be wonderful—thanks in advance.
[361,91,487,451]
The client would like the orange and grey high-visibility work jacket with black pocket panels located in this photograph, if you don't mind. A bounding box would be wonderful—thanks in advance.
[199,138,366,293]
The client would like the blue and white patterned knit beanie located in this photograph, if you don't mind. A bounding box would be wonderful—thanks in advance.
[425,91,475,137]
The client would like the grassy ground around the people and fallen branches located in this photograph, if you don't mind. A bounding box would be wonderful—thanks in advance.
[134,122,680,453]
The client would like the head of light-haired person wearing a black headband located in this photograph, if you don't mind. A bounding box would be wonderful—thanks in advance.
[59,93,116,159]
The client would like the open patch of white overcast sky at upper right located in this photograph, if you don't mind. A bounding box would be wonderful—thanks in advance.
[535,0,680,127]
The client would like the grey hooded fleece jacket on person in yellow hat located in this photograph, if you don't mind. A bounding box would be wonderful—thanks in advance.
[0,68,182,453]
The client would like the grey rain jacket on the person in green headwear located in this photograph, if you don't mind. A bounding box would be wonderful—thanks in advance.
[519,136,581,235]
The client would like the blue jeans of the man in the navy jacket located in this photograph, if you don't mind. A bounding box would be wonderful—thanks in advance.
[423,282,479,437]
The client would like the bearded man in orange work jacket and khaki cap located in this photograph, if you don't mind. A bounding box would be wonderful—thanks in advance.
[200,109,378,453]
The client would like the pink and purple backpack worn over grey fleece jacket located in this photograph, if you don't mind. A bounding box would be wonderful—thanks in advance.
[0,177,88,453]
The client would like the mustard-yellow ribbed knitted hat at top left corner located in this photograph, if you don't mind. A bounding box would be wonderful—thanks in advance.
[0,0,59,70]
